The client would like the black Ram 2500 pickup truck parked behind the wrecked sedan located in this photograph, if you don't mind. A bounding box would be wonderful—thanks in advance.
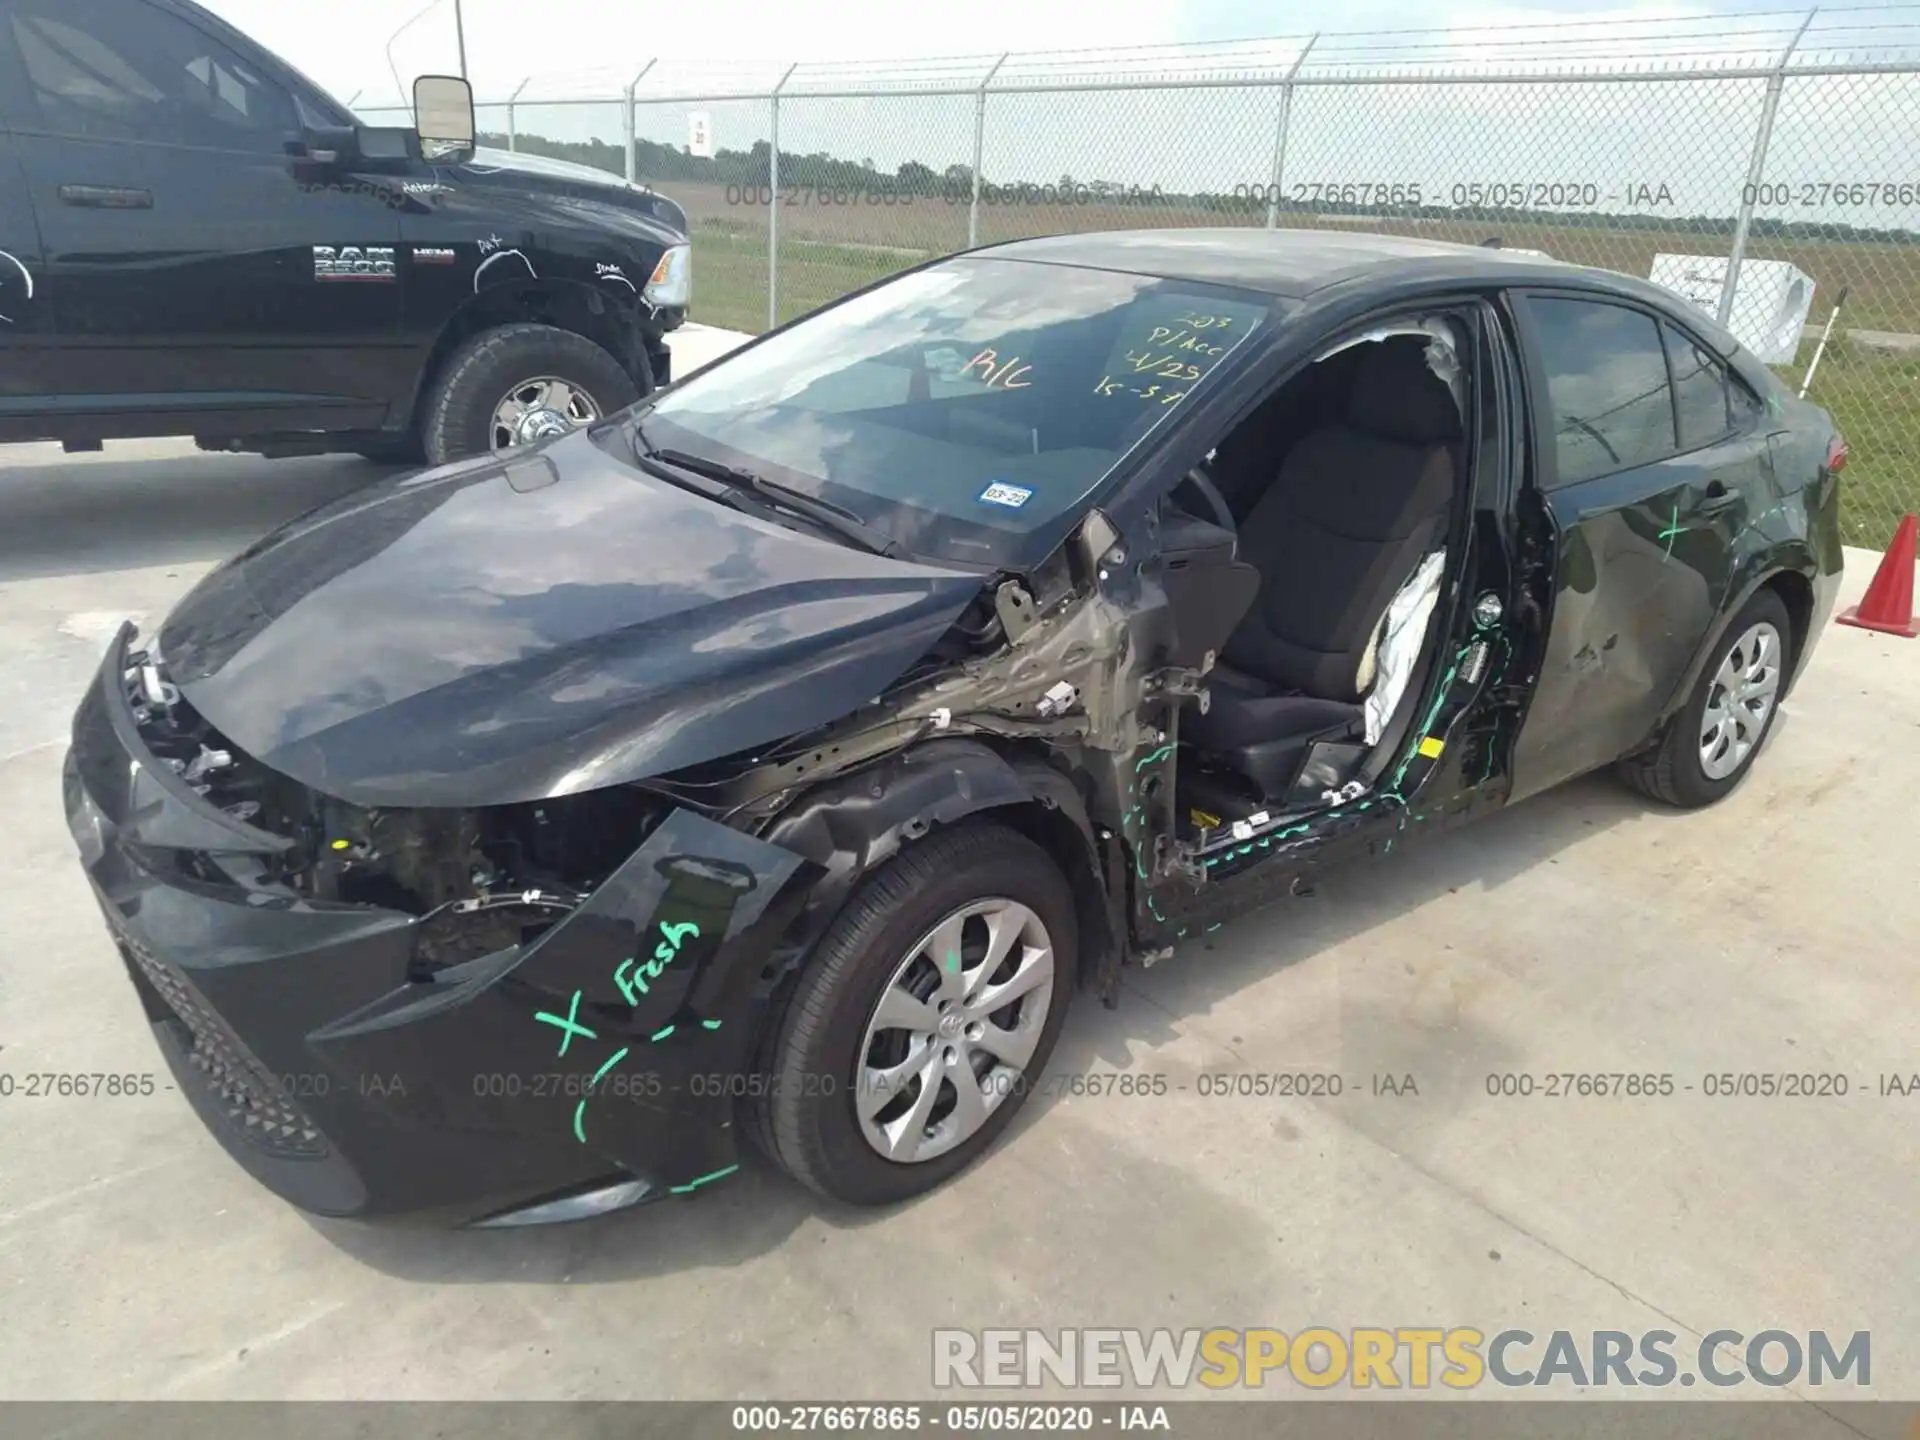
[0,0,693,465]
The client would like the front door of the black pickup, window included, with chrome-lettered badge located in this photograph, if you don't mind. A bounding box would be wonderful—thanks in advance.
[0,0,399,434]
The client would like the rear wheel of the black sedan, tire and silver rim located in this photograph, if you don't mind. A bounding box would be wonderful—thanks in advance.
[1619,589,1793,810]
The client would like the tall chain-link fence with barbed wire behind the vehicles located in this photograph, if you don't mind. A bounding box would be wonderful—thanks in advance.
[361,6,1920,547]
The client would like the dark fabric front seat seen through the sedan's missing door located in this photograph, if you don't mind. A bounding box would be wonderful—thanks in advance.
[1183,340,1461,801]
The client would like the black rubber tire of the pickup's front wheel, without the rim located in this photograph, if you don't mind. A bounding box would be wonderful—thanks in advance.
[420,324,639,465]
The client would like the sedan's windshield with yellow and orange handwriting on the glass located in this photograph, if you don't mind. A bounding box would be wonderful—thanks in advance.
[636,257,1271,564]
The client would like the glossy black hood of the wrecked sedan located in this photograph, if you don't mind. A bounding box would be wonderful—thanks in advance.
[159,430,983,806]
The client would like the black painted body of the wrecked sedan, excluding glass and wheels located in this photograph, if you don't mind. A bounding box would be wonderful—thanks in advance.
[67,232,1841,1219]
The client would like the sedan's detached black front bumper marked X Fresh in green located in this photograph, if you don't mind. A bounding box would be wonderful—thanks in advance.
[65,626,820,1223]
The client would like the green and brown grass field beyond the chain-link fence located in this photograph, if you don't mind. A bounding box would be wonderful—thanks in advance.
[674,186,1920,549]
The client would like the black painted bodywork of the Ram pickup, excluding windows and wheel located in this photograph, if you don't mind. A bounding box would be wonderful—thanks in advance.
[0,0,685,447]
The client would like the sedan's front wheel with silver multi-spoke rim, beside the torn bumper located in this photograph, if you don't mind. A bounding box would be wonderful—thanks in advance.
[749,824,1079,1206]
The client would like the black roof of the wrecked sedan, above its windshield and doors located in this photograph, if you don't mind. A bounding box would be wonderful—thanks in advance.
[966,225,1740,353]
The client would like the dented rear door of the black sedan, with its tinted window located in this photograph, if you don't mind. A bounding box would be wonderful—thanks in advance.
[1515,292,1766,799]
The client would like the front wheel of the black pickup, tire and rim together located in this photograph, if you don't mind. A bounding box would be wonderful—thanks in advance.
[420,324,639,465]
